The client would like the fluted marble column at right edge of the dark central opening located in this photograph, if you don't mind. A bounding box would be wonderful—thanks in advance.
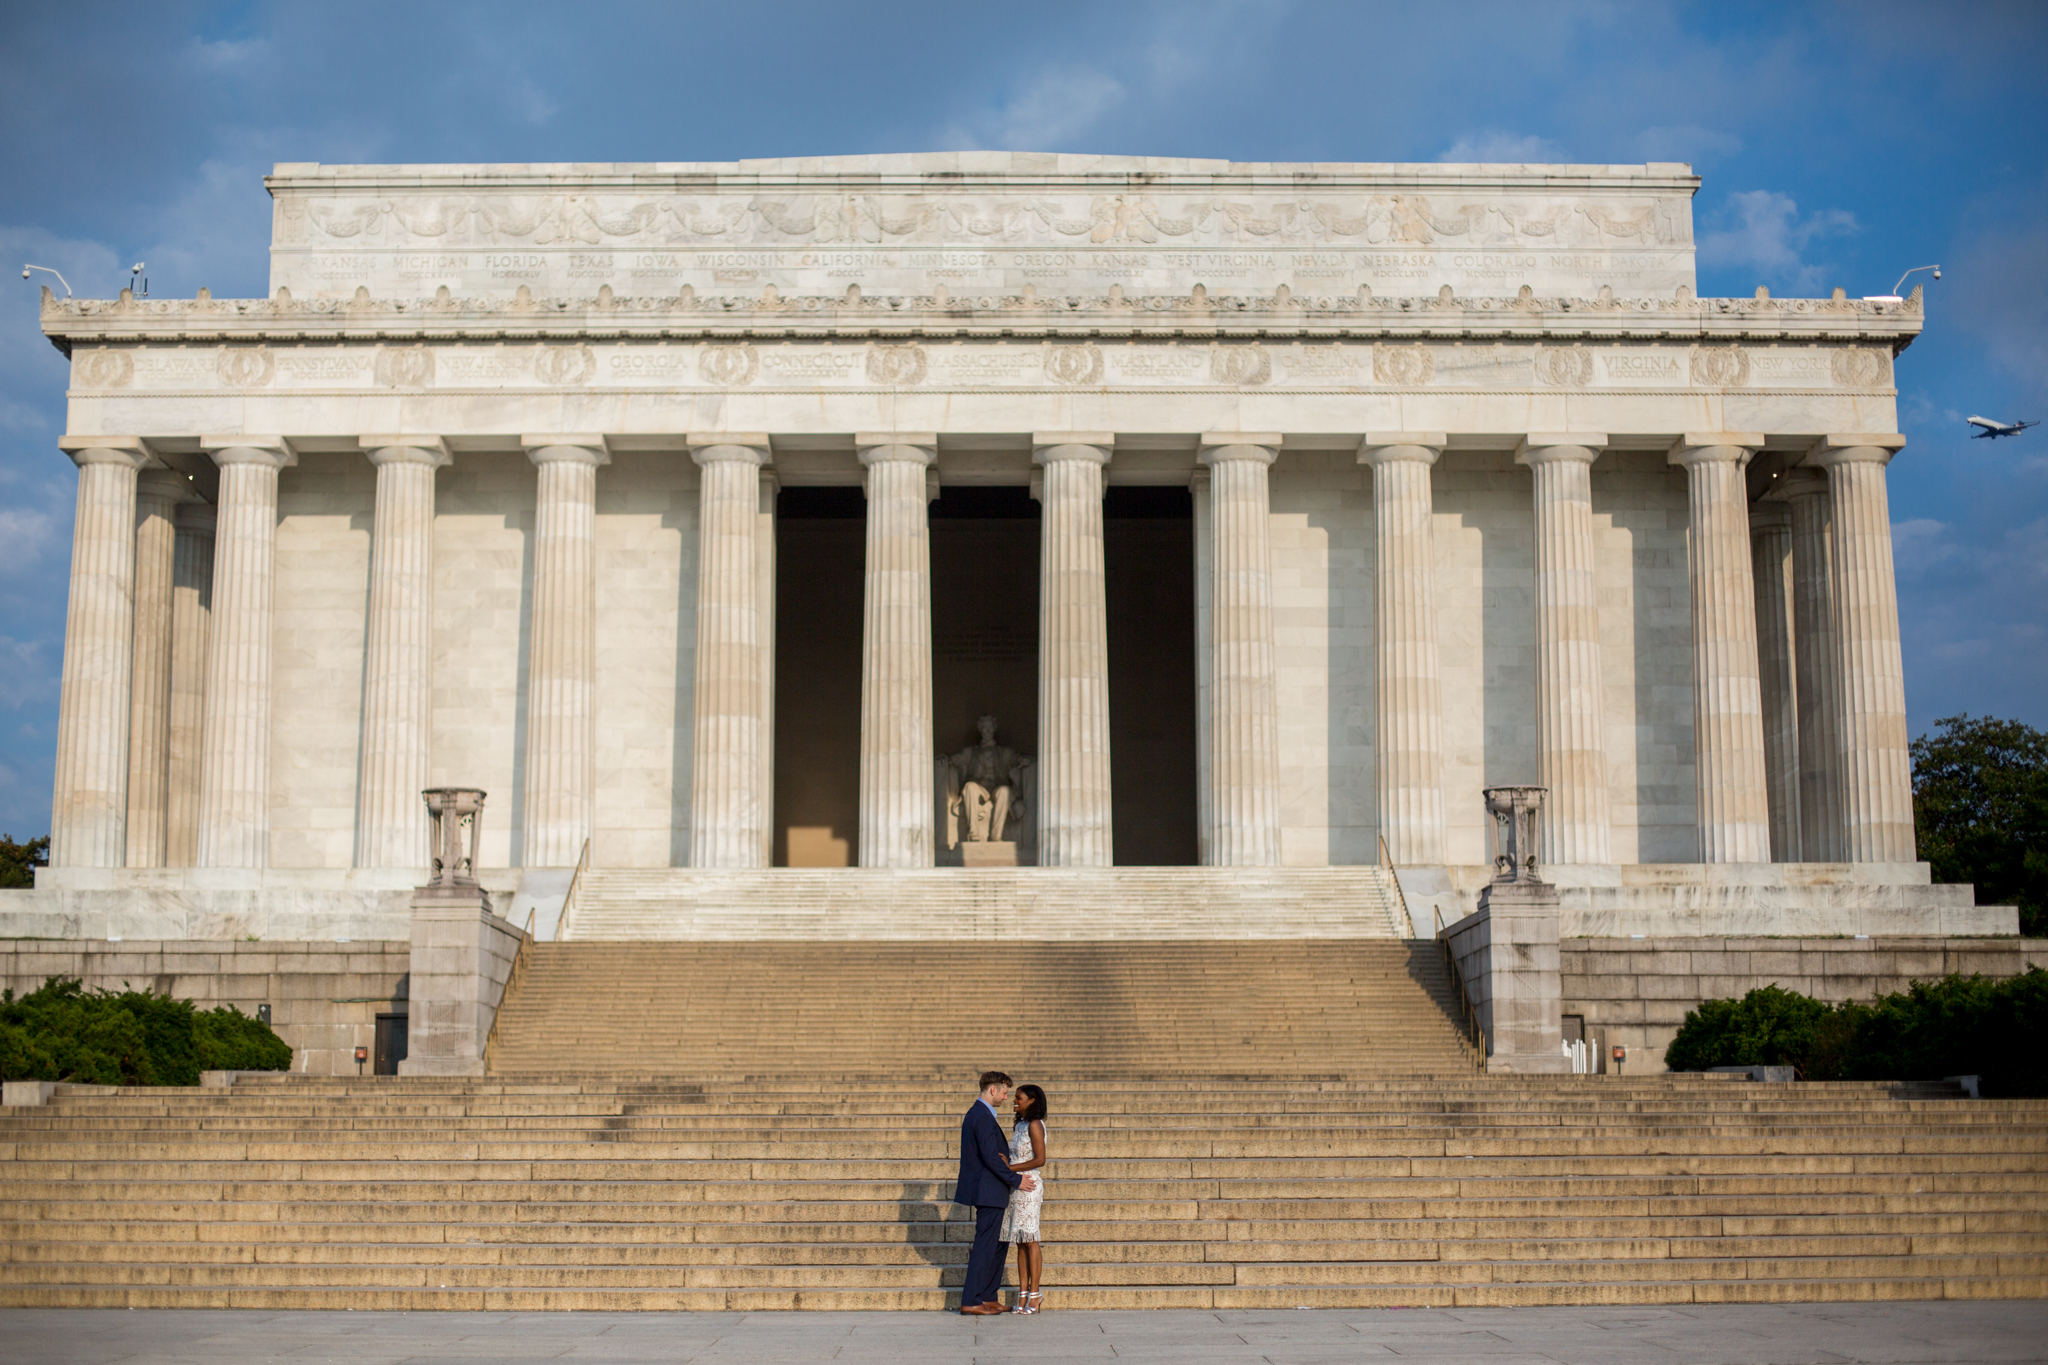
[1200,432,1280,868]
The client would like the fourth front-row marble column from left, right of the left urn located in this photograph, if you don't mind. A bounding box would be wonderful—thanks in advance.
[520,436,610,868]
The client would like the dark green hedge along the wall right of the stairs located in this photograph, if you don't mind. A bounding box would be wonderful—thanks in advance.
[1665,968,2048,1095]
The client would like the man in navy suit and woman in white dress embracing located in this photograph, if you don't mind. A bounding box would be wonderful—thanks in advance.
[952,1070,1047,1316]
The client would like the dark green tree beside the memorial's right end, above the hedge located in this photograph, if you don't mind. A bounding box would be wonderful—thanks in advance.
[1913,716,2048,937]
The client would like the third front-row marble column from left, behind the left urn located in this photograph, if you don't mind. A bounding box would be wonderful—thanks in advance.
[356,436,449,868]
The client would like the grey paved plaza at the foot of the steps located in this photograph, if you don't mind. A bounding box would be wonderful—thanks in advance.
[0,1302,2048,1365]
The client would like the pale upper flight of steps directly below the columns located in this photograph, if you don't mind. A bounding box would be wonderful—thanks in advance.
[557,868,1427,941]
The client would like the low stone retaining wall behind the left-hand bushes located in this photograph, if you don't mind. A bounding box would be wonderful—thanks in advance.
[0,939,412,1076]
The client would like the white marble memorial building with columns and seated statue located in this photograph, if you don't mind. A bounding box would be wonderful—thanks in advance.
[0,153,2015,961]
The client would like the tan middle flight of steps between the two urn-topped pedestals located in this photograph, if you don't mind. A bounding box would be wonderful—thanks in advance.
[487,937,1475,1085]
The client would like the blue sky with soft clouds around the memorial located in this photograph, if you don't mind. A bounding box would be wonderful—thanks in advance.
[0,0,2048,837]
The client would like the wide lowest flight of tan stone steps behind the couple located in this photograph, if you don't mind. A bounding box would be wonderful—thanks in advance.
[0,1080,2048,1312]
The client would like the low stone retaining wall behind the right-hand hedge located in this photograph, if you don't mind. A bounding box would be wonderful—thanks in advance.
[1559,937,2048,1072]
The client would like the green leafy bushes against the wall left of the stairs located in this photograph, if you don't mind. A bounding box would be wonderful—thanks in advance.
[0,976,291,1085]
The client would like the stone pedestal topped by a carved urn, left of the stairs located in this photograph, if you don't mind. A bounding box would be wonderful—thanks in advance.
[397,788,524,1076]
